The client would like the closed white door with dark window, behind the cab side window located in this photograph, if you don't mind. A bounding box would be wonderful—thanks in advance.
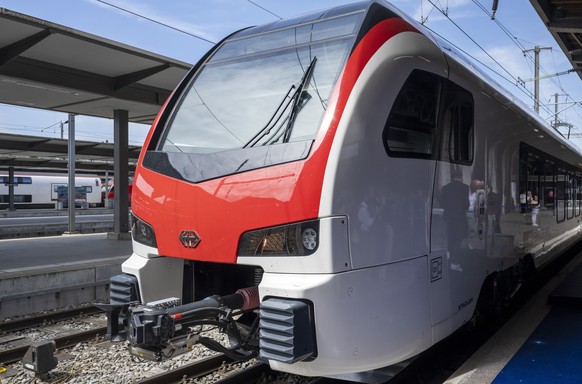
[429,75,487,326]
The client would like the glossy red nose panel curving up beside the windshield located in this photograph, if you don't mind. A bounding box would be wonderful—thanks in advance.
[132,18,415,263]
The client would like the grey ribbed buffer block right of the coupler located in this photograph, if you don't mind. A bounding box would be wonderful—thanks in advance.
[259,299,316,364]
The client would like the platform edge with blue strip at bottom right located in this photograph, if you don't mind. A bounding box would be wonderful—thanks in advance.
[445,249,582,384]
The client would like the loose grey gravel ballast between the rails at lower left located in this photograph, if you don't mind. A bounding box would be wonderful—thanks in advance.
[0,311,328,384]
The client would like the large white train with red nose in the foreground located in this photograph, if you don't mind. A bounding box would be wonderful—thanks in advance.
[98,0,582,377]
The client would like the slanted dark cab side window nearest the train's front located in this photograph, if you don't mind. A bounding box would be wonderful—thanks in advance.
[383,70,442,159]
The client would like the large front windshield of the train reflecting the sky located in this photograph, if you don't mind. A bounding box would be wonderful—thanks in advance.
[158,12,362,155]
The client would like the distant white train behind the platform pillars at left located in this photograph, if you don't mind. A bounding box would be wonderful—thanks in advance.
[0,173,103,209]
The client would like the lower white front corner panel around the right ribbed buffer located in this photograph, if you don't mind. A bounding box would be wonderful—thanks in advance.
[260,257,432,376]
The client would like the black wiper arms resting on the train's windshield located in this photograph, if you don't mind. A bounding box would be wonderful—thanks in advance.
[243,56,317,148]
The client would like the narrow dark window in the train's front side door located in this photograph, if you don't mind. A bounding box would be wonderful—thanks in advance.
[441,82,474,164]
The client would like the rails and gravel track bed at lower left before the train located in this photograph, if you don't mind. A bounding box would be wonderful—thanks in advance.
[0,307,286,384]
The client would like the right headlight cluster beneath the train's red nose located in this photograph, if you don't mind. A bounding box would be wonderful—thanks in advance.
[238,220,319,256]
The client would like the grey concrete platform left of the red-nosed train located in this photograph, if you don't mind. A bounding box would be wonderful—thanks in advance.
[0,233,131,321]
